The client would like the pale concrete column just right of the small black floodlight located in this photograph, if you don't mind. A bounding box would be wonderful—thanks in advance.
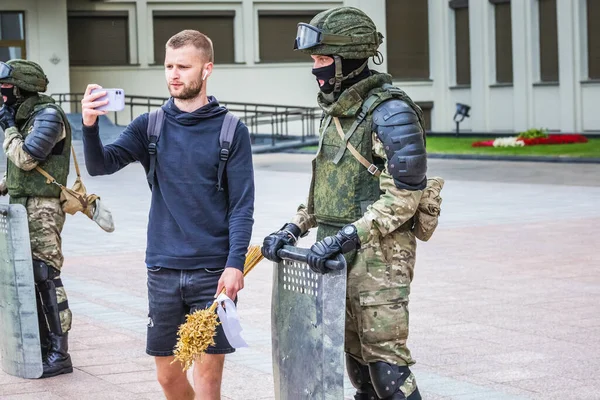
[469,0,494,132]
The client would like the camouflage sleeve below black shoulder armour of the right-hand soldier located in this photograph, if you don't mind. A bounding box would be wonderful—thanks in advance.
[354,133,423,243]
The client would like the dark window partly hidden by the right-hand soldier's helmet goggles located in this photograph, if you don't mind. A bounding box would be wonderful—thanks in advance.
[258,10,320,63]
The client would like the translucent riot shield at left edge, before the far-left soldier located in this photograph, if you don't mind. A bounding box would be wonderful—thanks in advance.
[0,204,43,378]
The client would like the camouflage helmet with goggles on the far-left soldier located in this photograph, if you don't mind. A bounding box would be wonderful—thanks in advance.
[0,59,48,92]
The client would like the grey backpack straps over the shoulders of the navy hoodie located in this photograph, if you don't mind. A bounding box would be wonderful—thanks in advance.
[146,108,240,192]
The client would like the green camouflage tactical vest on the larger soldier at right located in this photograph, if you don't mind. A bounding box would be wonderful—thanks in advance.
[308,74,424,227]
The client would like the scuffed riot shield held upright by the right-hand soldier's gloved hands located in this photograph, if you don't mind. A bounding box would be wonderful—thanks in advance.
[271,246,346,400]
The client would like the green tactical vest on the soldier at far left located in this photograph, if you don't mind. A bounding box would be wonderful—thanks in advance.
[6,96,71,203]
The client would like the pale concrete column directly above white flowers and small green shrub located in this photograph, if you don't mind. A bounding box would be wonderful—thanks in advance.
[510,0,537,132]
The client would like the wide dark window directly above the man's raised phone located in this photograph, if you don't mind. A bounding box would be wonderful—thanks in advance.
[68,11,129,65]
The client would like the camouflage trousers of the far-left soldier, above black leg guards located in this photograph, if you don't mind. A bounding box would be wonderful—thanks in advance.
[11,197,72,333]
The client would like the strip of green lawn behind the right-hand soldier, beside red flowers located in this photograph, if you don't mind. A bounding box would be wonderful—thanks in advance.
[301,136,600,158]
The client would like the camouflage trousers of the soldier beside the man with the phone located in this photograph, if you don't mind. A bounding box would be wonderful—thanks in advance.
[317,225,416,366]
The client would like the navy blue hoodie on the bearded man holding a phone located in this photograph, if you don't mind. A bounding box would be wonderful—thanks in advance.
[83,96,254,270]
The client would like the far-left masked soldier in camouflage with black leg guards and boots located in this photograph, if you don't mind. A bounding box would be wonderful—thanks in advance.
[0,60,73,378]
